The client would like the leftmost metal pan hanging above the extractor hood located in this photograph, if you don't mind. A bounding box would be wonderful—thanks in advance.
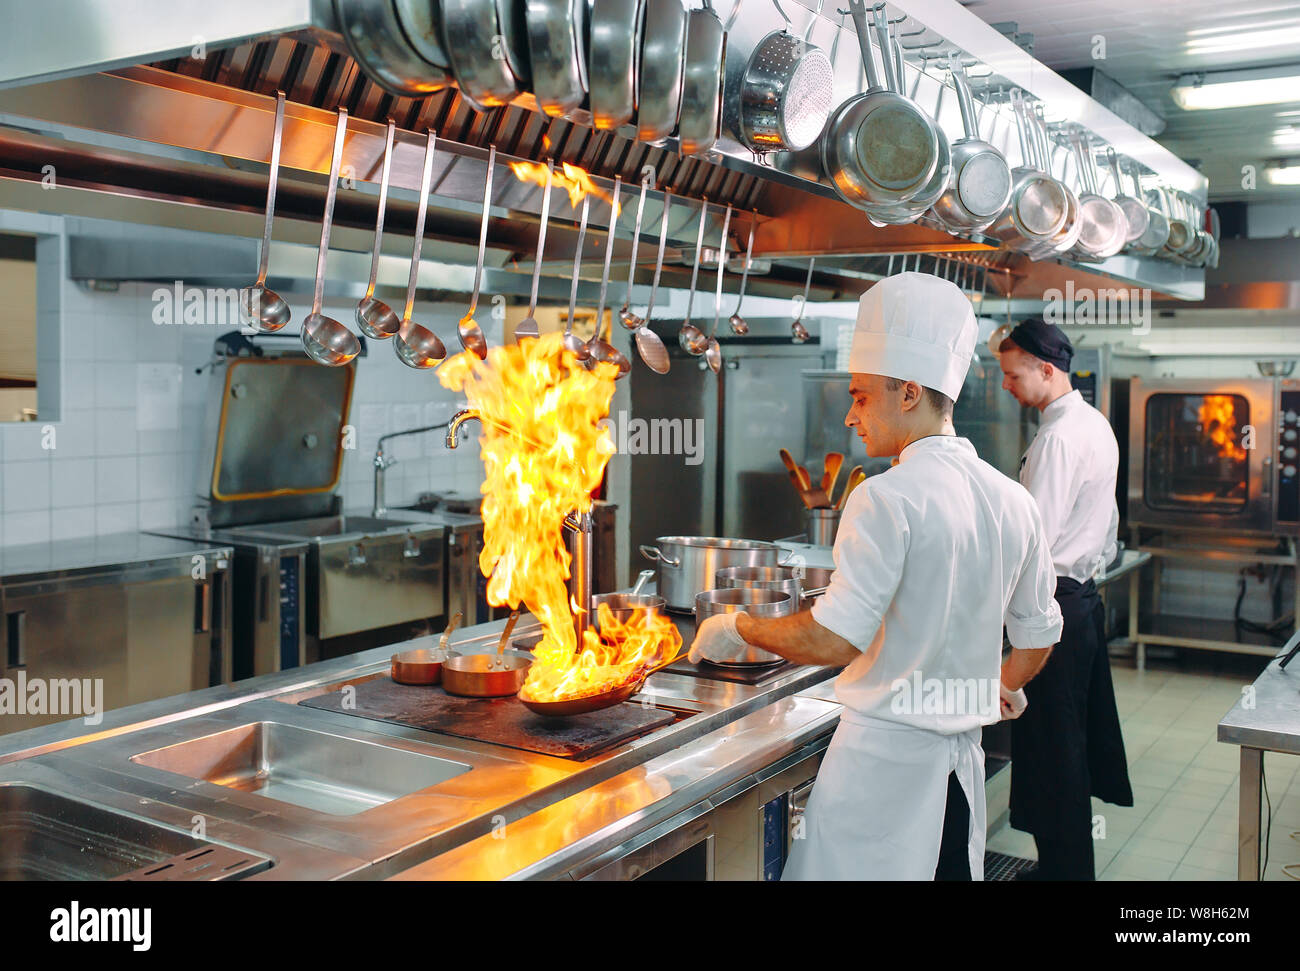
[334,0,451,97]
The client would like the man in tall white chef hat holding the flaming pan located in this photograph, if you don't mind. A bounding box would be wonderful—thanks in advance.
[690,273,1061,880]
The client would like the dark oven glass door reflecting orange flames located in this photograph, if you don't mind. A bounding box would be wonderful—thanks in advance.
[1145,393,1251,516]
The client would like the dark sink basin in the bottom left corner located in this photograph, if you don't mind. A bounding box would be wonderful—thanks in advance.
[0,783,269,880]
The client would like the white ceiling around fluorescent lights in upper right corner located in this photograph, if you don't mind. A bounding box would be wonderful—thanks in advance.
[961,0,1300,201]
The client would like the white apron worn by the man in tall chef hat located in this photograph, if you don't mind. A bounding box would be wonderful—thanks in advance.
[781,708,985,880]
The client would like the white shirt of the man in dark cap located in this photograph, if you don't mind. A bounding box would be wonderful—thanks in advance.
[1021,391,1119,584]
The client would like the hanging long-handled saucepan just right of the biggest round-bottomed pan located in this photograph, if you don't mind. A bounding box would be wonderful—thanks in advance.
[933,55,1011,231]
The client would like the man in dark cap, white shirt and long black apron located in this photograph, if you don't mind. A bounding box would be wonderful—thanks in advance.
[997,317,1134,880]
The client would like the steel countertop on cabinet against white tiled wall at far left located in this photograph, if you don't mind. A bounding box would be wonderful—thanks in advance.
[0,533,231,584]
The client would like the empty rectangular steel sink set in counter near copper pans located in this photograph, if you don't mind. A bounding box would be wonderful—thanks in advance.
[131,721,471,816]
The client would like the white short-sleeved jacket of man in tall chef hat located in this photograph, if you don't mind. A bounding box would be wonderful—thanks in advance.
[813,435,1061,734]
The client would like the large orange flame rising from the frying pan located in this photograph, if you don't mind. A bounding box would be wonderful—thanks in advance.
[439,334,681,701]
